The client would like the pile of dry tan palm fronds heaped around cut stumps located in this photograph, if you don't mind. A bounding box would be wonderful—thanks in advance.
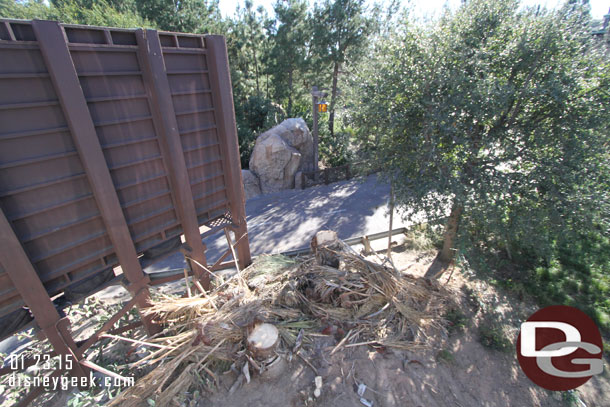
[113,242,449,406]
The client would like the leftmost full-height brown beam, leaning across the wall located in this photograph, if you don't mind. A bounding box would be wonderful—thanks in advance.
[32,20,159,334]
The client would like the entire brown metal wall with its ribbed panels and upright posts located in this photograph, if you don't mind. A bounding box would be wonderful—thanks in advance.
[0,20,249,332]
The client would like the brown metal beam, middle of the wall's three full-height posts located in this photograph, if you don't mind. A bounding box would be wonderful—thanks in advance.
[136,30,210,290]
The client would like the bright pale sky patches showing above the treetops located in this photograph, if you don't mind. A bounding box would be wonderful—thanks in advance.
[220,0,610,19]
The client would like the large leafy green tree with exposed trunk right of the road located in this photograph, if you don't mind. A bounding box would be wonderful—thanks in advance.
[351,0,610,275]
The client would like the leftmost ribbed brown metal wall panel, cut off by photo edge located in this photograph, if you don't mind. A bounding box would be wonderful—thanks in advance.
[0,30,113,312]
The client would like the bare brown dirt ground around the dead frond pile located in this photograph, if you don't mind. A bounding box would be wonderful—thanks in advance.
[5,241,610,407]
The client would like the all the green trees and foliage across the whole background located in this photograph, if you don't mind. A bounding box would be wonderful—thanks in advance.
[0,0,610,332]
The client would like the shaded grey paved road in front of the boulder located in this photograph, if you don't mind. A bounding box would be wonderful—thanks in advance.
[147,175,404,272]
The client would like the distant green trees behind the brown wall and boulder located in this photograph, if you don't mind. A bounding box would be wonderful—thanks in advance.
[0,0,375,168]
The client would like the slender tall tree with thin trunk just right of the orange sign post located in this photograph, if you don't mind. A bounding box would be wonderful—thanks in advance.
[312,0,374,137]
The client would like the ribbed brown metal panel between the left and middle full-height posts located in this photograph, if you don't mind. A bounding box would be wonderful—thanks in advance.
[66,28,181,252]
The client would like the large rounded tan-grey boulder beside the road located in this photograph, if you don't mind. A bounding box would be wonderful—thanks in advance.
[250,118,313,194]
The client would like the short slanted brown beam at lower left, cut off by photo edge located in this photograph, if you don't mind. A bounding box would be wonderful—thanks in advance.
[0,211,87,376]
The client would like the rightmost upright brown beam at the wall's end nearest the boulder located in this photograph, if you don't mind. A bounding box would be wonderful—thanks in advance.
[205,35,252,269]
